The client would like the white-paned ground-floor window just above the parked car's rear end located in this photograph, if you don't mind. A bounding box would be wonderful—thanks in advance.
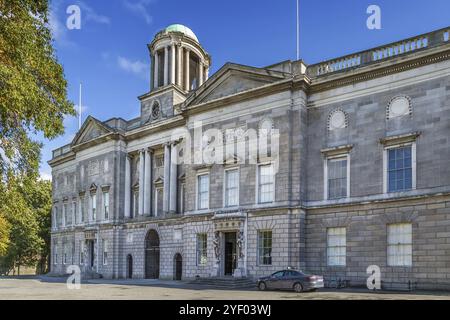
[327,228,347,266]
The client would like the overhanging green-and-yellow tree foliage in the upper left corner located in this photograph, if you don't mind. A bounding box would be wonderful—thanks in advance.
[0,0,75,180]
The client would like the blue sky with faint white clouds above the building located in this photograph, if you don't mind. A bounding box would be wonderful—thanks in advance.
[37,0,450,177]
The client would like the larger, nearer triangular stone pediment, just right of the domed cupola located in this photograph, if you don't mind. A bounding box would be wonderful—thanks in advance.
[185,64,285,106]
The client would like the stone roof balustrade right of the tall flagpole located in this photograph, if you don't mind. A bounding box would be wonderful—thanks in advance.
[307,28,450,77]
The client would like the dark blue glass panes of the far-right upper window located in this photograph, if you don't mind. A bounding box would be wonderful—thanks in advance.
[387,146,413,192]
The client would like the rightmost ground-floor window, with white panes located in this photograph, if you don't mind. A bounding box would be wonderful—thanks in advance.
[387,223,412,267]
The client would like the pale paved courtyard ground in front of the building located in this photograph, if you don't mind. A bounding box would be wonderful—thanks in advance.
[0,277,450,300]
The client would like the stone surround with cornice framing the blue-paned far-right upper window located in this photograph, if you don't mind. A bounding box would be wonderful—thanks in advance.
[380,132,421,194]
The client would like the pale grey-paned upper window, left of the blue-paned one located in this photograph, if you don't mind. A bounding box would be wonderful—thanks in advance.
[327,157,348,199]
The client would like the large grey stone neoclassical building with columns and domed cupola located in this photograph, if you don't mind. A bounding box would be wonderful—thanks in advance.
[49,25,450,289]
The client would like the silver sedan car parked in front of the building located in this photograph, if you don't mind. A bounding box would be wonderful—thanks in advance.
[257,270,324,292]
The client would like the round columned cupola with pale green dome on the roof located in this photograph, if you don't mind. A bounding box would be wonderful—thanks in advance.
[149,24,211,92]
